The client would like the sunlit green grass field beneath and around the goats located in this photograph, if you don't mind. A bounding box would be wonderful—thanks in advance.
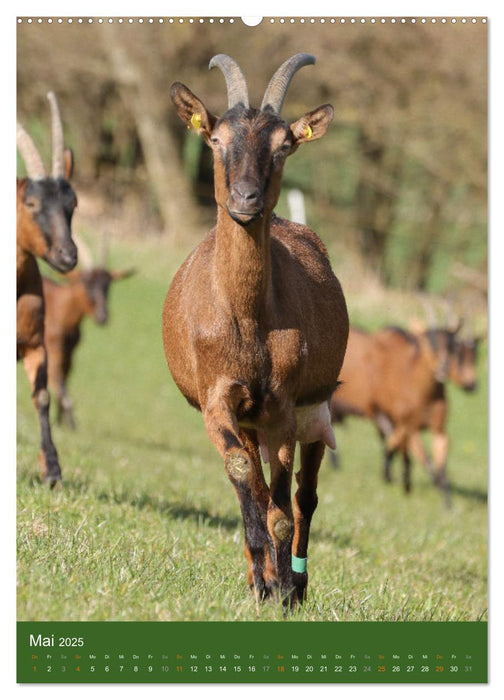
[17,239,487,621]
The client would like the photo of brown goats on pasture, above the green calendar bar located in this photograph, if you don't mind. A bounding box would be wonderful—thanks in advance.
[16,17,488,622]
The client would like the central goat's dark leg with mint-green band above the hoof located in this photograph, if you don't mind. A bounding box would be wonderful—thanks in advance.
[292,442,325,601]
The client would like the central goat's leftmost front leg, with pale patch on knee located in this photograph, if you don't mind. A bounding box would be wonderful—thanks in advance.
[203,384,277,600]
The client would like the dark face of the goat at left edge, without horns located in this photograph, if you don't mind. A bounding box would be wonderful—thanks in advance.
[20,177,77,272]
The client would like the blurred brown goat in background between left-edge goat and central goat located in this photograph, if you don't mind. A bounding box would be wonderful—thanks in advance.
[42,262,133,429]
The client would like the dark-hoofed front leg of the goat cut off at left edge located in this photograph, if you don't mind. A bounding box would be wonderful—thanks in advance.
[23,345,61,488]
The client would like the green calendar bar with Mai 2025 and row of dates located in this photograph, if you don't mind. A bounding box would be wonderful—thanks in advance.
[17,622,487,683]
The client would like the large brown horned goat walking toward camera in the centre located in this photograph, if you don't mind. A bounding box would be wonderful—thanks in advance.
[163,54,348,608]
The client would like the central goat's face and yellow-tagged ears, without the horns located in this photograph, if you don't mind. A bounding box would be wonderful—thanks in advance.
[171,83,334,226]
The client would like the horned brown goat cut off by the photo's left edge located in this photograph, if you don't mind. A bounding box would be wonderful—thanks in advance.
[16,93,77,486]
